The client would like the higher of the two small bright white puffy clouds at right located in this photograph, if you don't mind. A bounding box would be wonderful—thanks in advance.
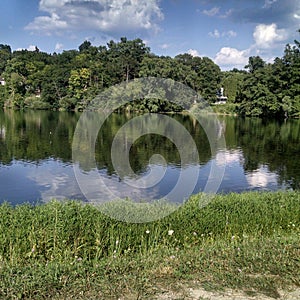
[253,23,287,48]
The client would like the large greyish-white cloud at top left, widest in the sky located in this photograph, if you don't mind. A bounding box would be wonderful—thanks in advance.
[25,0,163,35]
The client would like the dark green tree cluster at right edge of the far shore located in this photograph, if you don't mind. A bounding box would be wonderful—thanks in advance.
[235,31,300,118]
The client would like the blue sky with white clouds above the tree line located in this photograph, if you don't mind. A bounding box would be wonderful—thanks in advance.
[0,0,300,70]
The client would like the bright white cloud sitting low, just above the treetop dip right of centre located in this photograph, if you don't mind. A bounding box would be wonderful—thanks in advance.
[215,47,249,67]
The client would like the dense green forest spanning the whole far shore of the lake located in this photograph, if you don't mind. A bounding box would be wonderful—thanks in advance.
[0,31,300,117]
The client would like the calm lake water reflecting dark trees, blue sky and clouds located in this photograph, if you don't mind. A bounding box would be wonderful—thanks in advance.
[0,111,300,204]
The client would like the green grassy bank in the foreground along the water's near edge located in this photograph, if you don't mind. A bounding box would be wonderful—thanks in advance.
[0,192,300,299]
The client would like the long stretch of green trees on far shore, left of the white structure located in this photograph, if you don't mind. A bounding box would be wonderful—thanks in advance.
[0,37,221,112]
